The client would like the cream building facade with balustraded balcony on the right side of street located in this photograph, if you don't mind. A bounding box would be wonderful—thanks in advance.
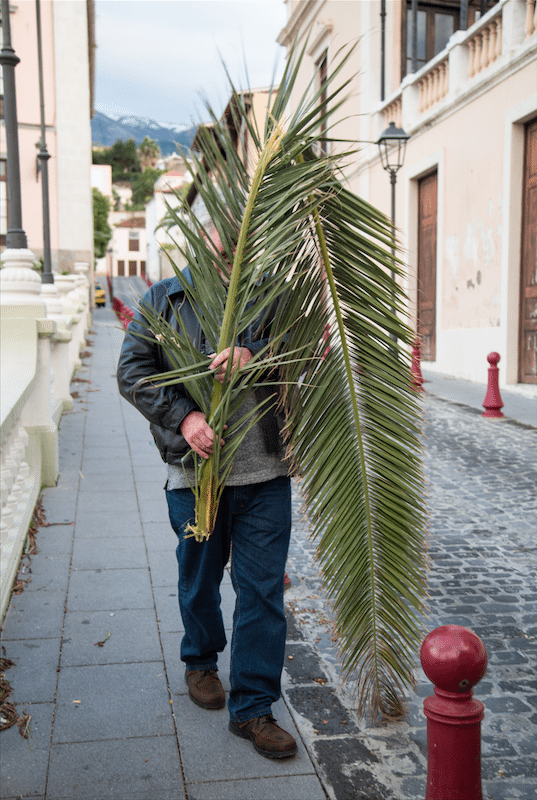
[278,0,537,394]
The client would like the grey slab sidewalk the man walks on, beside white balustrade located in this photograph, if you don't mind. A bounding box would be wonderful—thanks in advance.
[0,305,326,800]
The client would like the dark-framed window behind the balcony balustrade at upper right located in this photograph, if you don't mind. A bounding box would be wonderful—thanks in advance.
[401,0,496,78]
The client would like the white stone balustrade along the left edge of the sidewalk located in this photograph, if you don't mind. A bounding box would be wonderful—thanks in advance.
[0,250,89,619]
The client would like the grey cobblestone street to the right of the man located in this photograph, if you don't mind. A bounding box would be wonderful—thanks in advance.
[287,396,537,800]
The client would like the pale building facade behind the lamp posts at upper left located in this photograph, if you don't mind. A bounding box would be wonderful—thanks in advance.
[0,0,93,272]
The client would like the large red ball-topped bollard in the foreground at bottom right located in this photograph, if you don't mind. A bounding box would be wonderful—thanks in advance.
[421,625,487,800]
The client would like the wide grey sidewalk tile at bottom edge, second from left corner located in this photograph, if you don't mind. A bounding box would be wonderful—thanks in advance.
[46,736,185,800]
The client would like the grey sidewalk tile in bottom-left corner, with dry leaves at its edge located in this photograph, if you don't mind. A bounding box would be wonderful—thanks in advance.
[0,703,53,800]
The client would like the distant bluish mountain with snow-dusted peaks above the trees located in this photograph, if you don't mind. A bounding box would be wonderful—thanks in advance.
[91,111,196,156]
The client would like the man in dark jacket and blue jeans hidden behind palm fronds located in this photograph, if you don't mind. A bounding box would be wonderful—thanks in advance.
[118,268,297,758]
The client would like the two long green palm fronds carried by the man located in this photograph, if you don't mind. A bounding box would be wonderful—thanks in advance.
[140,42,426,717]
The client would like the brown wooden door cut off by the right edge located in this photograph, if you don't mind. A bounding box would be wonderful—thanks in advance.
[518,119,537,383]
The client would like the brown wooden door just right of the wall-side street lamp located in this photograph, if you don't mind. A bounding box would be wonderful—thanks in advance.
[418,172,438,361]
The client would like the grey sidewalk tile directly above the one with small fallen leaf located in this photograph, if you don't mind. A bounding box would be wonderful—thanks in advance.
[67,569,153,611]
